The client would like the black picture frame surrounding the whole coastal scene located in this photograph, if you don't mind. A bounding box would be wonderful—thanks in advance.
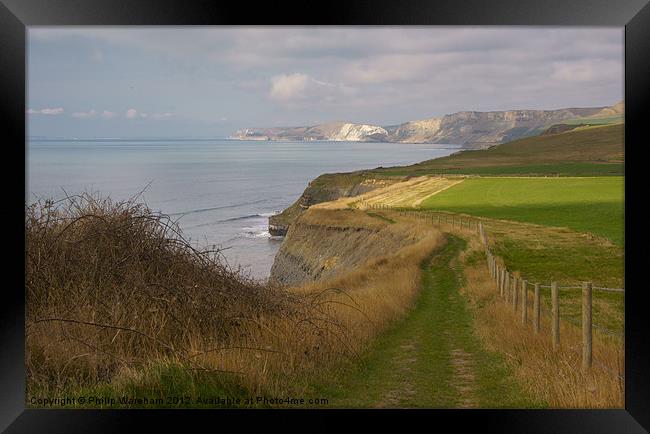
[0,0,650,433]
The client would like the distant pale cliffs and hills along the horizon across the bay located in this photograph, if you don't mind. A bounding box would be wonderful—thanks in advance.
[232,102,623,149]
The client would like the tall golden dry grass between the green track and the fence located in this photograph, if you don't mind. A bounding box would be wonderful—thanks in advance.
[462,237,624,408]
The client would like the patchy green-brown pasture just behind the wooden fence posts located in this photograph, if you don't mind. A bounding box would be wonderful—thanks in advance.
[390,207,625,350]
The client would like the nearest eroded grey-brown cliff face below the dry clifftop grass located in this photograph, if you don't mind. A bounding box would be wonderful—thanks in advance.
[270,209,420,286]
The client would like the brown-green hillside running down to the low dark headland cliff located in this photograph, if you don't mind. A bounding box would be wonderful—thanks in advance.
[269,124,624,231]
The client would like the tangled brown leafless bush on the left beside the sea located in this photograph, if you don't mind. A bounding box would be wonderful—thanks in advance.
[25,194,306,389]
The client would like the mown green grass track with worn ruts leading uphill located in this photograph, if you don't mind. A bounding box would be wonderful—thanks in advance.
[321,235,543,408]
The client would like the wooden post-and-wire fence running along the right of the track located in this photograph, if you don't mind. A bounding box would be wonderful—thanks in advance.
[362,201,625,379]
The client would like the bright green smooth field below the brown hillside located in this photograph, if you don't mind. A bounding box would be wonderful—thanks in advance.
[422,176,624,245]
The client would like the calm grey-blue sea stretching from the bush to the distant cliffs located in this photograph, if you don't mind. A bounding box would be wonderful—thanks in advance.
[27,140,459,279]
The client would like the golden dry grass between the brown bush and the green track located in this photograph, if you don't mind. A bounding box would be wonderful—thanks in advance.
[195,211,443,394]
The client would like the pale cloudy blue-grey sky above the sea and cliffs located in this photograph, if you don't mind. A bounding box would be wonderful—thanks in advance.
[27,26,624,138]
